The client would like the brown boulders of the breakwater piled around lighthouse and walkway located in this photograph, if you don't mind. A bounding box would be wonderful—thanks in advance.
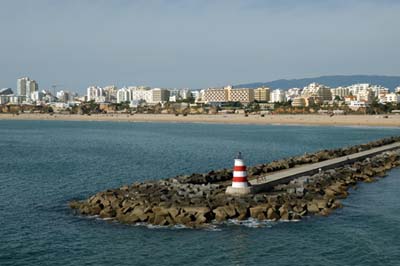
[69,137,400,228]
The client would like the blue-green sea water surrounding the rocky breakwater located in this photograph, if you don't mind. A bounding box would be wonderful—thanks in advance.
[0,121,400,266]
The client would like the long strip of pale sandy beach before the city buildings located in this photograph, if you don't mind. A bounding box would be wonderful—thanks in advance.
[0,114,400,127]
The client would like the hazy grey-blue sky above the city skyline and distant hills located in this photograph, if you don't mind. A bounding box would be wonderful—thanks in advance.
[0,0,400,92]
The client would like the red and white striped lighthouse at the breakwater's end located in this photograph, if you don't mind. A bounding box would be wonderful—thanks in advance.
[226,152,251,195]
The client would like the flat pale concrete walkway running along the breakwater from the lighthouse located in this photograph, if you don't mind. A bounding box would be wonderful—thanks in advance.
[249,142,400,193]
